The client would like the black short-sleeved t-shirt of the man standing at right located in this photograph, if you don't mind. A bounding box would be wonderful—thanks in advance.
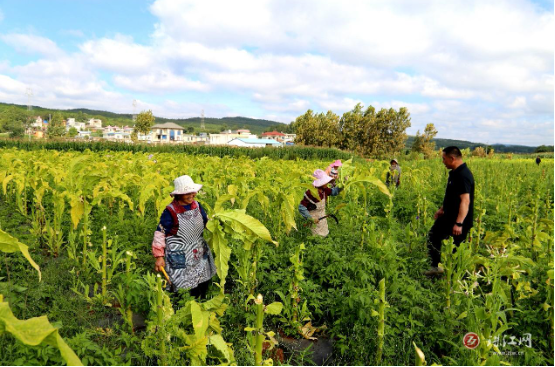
[443,163,474,228]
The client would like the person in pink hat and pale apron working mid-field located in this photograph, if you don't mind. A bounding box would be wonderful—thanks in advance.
[299,169,343,237]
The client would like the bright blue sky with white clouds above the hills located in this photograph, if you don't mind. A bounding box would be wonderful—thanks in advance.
[0,0,555,146]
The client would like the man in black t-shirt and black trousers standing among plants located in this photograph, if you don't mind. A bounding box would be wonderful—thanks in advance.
[424,146,474,276]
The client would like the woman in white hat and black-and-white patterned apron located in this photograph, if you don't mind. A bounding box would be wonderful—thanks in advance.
[152,176,216,299]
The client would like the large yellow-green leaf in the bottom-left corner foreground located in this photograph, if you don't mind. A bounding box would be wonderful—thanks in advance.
[0,296,83,366]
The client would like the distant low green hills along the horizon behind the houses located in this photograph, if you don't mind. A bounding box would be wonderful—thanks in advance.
[0,102,536,153]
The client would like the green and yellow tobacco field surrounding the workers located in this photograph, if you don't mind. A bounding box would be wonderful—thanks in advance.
[0,148,554,365]
